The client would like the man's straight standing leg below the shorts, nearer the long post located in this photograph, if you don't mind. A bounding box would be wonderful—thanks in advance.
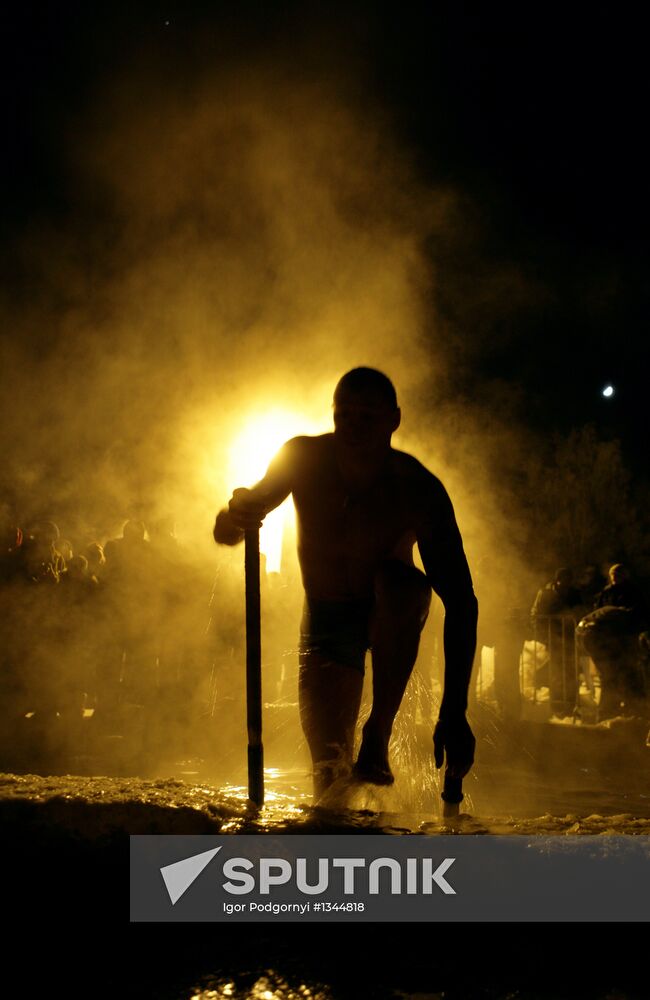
[299,650,363,799]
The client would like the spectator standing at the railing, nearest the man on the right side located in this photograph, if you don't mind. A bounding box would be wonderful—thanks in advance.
[531,566,582,717]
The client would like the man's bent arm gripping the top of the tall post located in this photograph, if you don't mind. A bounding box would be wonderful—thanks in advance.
[213,438,301,545]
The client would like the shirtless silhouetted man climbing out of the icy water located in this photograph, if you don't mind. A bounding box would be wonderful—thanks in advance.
[214,368,478,797]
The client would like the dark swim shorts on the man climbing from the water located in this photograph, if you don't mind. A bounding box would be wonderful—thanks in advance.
[300,599,374,673]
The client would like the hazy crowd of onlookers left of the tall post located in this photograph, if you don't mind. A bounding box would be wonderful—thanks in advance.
[0,520,224,760]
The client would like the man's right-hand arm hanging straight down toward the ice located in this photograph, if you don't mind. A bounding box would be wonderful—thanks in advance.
[417,477,478,778]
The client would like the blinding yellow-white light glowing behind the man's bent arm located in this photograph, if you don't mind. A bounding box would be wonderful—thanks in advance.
[231,410,306,573]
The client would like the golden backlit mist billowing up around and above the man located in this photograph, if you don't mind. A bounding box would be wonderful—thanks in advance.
[0,15,640,796]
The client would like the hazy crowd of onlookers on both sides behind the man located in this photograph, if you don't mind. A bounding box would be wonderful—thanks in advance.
[0,504,650,768]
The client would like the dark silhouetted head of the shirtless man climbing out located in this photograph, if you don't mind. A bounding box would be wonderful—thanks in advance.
[334,368,401,452]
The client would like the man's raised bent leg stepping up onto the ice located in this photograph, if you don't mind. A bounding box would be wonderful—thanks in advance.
[355,560,431,785]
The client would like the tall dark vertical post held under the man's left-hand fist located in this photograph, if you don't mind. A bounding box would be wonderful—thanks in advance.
[245,528,264,806]
